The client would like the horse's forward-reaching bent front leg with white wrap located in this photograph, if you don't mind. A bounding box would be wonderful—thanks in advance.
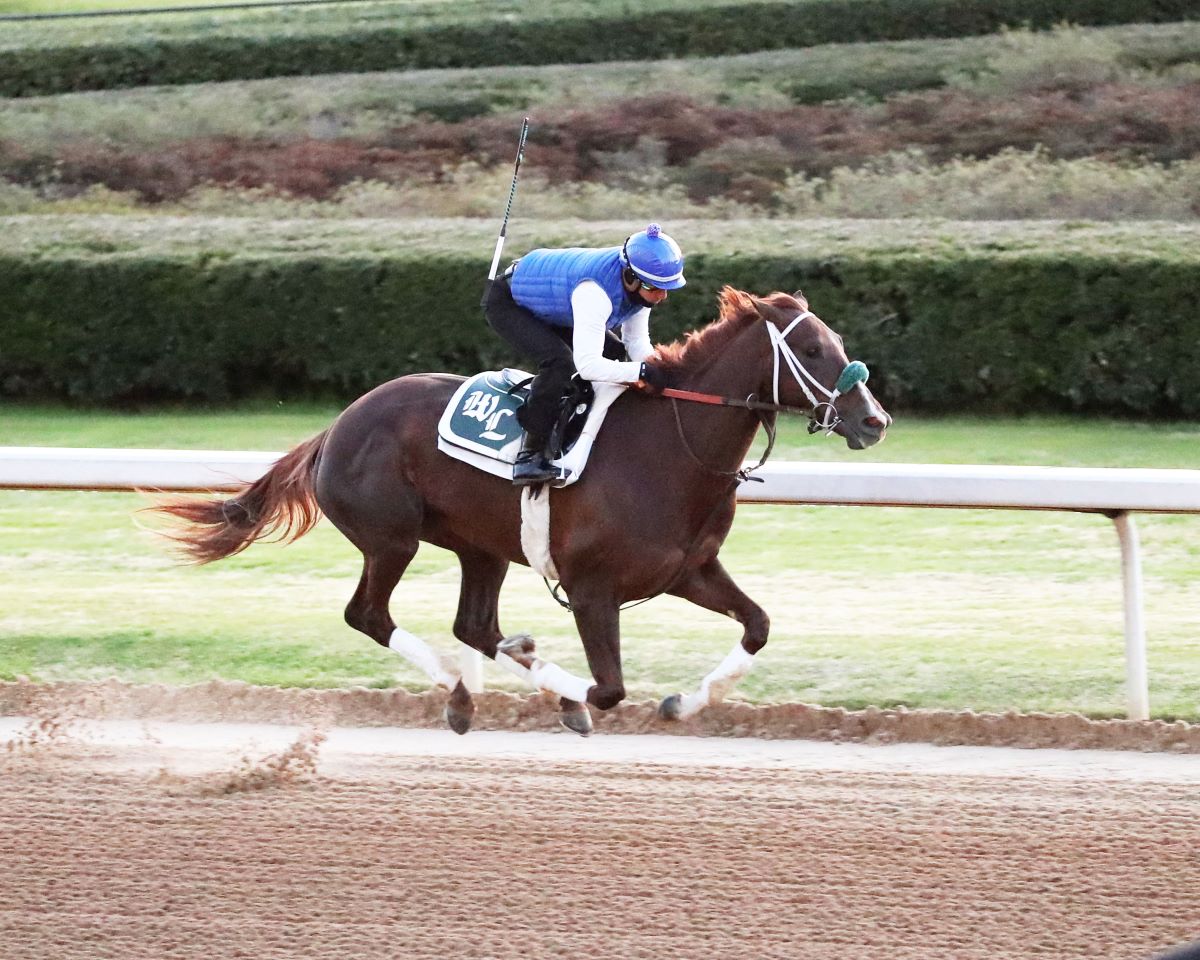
[659,557,770,720]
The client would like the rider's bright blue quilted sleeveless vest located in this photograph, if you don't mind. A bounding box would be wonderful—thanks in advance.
[509,247,641,330]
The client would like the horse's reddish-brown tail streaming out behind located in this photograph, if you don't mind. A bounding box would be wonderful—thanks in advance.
[151,430,329,564]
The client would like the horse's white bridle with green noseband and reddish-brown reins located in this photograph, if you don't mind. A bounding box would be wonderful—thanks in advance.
[660,310,870,482]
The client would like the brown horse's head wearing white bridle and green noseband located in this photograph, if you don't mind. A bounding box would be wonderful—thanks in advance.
[720,287,892,450]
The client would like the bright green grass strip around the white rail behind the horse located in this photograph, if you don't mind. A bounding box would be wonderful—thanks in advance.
[0,404,1200,719]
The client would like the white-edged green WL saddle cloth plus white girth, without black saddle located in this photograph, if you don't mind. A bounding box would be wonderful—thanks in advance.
[438,368,628,580]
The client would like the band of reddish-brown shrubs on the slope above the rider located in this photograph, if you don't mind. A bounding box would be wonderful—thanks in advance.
[0,83,1200,202]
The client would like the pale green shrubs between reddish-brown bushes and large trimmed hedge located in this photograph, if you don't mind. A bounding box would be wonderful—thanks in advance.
[9,149,1200,223]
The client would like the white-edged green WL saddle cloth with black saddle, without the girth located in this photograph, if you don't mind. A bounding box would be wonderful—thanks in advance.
[438,368,626,487]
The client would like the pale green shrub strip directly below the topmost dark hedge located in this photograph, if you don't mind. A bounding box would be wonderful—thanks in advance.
[9,20,1200,148]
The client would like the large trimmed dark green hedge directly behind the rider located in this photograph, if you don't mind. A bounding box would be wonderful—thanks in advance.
[0,217,1200,416]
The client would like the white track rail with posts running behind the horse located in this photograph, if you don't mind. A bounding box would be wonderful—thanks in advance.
[0,446,1200,720]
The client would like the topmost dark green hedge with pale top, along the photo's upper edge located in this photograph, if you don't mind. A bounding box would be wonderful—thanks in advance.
[0,0,1200,96]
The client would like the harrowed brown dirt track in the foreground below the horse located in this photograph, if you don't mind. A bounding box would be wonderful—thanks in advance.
[0,716,1200,960]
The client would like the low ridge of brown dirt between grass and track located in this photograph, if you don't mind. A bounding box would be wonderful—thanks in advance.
[0,679,1200,754]
